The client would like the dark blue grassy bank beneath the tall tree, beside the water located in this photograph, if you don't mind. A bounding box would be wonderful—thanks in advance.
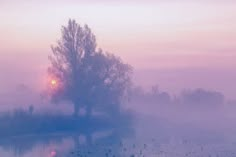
[0,112,128,137]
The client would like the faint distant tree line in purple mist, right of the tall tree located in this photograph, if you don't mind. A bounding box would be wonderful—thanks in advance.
[130,86,225,107]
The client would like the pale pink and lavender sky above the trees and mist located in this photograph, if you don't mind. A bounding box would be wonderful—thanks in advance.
[0,0,236,99]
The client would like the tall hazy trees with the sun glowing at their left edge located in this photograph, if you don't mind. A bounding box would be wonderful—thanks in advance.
[48,19,132,115]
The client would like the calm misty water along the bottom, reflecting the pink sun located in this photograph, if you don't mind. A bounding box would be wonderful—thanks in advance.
[0,125,236,157]
